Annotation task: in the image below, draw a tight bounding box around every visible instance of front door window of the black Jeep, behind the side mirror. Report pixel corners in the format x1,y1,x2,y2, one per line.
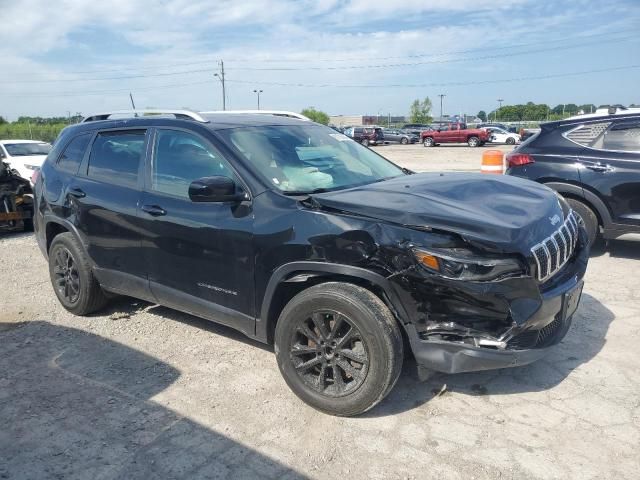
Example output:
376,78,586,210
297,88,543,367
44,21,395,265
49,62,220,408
151,129,236,198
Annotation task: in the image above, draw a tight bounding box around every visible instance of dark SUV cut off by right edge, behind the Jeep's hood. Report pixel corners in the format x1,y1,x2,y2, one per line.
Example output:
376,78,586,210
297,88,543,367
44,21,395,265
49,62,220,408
507,108,640,243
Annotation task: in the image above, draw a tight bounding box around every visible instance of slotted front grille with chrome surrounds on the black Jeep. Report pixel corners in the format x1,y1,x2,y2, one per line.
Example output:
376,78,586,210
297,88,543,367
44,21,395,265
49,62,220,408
531,210,578,282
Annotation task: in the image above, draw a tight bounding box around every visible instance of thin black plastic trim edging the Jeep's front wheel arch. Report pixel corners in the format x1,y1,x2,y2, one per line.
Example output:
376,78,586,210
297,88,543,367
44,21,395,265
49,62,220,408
255,262,408,342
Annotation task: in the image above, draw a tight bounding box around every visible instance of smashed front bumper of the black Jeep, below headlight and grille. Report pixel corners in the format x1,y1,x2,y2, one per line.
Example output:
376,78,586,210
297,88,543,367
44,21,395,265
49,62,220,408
389,228,588,373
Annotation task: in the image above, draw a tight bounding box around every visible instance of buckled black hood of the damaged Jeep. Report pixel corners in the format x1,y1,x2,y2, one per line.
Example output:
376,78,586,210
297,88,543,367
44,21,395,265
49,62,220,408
313,173,565,254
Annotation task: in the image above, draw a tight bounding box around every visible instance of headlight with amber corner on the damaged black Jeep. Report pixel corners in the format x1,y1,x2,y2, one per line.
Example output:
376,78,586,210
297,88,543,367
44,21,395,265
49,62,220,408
413,248,525,282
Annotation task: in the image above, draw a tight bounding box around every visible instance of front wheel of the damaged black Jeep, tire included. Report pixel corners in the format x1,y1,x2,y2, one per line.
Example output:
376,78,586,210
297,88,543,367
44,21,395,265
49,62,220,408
275,282,403,417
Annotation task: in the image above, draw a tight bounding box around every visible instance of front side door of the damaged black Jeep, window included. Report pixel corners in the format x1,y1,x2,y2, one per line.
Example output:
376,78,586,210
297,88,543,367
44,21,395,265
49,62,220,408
140,128,255,335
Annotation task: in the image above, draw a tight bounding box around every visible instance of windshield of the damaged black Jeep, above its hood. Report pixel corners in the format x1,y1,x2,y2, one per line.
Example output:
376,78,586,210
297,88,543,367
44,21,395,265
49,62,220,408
218,125,404,193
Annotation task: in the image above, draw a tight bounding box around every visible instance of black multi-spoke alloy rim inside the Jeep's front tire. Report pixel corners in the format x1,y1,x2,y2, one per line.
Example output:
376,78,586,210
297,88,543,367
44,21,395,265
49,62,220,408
290,310,369,397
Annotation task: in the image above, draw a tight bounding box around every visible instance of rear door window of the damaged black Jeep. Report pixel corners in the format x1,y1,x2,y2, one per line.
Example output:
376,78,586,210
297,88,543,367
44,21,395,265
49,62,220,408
87,130,145,186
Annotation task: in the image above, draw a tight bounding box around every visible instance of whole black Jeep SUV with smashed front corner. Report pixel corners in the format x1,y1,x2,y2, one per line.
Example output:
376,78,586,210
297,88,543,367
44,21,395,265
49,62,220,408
35,112,588,415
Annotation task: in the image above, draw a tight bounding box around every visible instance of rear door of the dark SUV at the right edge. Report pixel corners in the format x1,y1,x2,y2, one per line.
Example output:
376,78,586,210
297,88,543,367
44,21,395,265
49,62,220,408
579,119,640,226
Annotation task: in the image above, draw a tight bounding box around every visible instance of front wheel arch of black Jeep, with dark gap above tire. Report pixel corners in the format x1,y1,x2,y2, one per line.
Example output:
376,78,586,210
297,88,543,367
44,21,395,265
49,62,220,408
256,262,408,343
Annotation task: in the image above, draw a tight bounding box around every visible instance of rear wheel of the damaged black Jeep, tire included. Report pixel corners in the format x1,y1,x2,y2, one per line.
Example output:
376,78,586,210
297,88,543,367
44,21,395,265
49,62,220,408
49,233,107,315
